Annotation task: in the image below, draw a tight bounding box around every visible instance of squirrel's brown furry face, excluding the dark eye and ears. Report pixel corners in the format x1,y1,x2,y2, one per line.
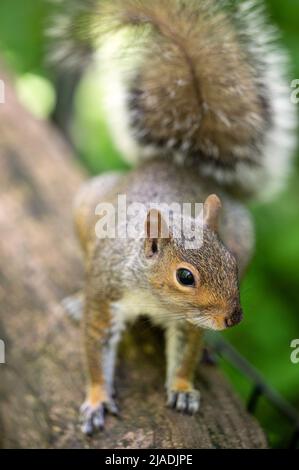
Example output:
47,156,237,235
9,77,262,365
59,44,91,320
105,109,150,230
149,227,242,330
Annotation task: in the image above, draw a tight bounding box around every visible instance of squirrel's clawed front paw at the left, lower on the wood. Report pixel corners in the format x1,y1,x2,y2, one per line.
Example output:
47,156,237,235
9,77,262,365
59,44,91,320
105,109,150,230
80,400,118,436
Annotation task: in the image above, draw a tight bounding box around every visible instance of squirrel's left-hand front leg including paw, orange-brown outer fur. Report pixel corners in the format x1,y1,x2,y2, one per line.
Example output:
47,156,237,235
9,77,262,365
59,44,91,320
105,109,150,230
81,300,121,434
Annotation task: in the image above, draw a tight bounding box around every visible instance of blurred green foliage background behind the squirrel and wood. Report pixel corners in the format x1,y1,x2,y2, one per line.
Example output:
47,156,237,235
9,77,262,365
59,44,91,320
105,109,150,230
0,0,299,446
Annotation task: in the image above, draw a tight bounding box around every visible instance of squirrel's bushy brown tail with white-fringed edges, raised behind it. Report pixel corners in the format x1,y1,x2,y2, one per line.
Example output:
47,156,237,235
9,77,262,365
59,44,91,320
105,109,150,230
51,0,296,195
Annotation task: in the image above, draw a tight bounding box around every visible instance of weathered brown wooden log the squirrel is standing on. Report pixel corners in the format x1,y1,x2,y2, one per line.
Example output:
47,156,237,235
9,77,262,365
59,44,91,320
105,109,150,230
0,69,266,448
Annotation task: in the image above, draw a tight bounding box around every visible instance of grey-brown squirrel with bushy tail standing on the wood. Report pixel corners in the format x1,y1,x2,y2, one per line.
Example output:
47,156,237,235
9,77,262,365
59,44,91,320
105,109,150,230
56,0,296,434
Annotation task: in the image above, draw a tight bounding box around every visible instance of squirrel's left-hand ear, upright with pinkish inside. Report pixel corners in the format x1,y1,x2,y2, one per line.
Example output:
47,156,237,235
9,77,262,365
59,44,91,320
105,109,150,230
145,209,171,258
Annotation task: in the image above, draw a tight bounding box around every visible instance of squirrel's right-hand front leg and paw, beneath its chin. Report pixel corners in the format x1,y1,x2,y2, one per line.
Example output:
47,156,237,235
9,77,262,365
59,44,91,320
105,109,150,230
166,323,203,414
